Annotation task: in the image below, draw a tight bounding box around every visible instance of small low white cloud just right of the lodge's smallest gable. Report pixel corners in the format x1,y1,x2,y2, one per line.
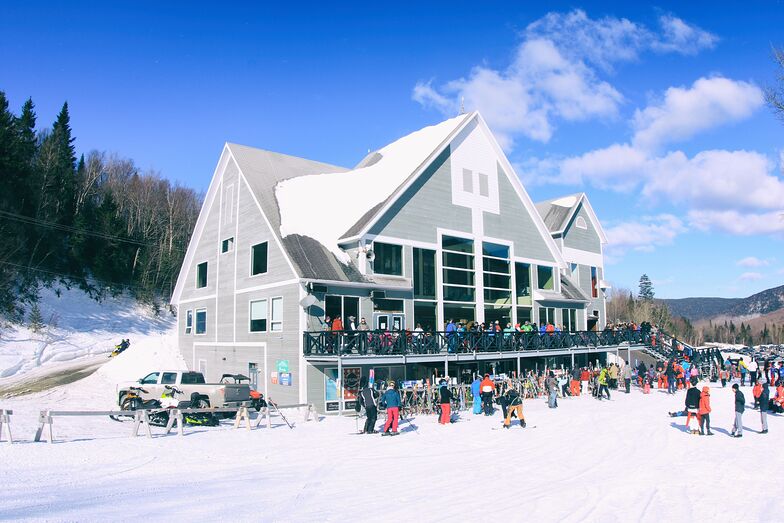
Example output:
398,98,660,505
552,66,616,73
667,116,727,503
605,214,686,257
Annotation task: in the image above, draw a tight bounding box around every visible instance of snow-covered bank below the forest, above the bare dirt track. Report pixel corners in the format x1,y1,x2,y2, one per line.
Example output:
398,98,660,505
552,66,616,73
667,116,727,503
0,288,176,389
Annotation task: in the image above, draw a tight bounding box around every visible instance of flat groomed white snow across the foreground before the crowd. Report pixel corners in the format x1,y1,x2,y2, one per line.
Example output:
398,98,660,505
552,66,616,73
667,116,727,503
0,374,784,522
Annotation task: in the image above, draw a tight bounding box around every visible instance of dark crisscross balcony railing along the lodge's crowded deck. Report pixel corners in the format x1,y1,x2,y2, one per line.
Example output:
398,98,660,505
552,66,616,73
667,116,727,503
303,330,650,356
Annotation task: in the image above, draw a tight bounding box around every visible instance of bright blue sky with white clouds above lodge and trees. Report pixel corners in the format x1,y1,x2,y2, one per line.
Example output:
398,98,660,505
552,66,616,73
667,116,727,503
0,1,784,297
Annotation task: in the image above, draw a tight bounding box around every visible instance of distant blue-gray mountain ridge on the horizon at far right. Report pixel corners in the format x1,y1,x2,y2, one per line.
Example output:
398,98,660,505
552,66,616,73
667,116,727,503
660,285,784,321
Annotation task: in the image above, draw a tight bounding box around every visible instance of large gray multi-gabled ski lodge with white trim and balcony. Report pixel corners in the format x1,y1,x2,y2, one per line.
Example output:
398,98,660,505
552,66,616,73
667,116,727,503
172,112,636,412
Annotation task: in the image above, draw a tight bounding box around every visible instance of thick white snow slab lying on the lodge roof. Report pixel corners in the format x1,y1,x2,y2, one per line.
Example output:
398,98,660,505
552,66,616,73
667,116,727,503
275,114,471,263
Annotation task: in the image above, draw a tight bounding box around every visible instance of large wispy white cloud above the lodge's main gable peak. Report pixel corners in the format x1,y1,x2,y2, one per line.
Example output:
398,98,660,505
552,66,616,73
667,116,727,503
412,10,715,150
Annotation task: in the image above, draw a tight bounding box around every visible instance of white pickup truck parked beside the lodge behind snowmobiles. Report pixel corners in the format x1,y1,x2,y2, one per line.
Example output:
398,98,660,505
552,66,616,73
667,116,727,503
117,370,250,408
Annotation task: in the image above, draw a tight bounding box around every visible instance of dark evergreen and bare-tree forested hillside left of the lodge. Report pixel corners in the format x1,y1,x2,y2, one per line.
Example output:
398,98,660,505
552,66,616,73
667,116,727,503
0,91,201,321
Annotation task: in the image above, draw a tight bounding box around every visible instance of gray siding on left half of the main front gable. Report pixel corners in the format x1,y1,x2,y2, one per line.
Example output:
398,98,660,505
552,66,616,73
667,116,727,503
370,148,471,243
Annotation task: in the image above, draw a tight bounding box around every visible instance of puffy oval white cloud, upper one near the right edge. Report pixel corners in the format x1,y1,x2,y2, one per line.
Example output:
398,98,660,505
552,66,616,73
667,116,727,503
632,77,764,150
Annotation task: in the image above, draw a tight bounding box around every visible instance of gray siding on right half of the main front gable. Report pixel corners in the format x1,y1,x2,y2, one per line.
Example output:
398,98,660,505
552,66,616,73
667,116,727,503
484,165,555,262
